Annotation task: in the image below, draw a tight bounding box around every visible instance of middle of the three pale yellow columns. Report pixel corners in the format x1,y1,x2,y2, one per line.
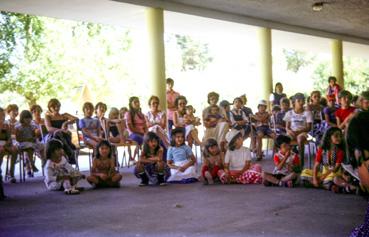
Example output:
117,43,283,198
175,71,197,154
258,27,273,101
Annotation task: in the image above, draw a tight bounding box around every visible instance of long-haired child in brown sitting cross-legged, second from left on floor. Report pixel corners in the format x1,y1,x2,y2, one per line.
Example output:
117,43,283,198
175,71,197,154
87,140,122,188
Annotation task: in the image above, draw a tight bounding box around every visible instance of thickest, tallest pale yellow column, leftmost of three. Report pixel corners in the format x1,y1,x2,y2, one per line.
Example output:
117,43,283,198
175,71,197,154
145,8,167,110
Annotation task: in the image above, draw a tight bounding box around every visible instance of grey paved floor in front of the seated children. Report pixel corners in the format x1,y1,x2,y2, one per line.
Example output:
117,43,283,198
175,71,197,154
0,155,367,237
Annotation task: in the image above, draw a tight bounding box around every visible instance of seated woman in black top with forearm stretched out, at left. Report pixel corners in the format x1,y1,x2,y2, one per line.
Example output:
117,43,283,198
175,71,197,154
45,99,78,164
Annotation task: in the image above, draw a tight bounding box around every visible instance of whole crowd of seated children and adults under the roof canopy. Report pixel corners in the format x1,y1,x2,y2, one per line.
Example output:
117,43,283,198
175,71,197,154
0,77,369,235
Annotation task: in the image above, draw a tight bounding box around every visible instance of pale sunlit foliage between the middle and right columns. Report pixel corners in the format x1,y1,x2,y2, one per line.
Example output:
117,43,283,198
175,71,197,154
283,49,315,73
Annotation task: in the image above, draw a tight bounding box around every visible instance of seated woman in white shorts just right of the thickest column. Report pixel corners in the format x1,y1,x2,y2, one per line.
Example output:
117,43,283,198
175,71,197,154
173,96,202,147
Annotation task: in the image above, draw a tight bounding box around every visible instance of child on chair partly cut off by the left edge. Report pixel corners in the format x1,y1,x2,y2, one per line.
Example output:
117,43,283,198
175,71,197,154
0,107,17,183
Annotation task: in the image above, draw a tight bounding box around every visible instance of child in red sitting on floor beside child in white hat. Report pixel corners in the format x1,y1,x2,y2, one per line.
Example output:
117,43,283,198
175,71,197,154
201,138,224,184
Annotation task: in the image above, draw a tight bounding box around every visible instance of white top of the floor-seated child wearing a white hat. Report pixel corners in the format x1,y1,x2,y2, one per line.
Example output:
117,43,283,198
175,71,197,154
224,147,251,170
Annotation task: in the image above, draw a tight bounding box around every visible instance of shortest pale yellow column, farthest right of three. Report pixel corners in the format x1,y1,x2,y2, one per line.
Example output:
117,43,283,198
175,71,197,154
331,39,344,88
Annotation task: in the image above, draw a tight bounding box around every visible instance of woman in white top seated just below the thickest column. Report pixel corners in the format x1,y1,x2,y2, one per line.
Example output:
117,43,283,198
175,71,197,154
145,95,169,148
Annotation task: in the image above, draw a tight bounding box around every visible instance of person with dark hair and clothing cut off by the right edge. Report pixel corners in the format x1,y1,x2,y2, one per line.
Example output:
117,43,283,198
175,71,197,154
347,98,369,237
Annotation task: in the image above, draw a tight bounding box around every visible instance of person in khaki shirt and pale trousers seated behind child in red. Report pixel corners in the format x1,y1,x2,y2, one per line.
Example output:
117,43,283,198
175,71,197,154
202,92,229,147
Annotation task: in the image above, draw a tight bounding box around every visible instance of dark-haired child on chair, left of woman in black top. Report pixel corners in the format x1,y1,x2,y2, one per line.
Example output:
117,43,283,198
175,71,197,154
15,110,44,177
